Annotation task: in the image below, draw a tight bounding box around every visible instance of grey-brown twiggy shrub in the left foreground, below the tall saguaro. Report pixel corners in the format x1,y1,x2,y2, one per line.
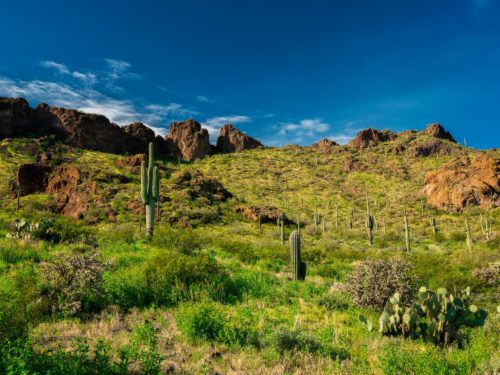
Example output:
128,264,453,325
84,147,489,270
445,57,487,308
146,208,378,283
40,253,107,315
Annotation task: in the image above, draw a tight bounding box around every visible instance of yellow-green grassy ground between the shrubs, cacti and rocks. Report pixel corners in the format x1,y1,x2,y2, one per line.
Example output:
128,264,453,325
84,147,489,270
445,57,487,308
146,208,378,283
0,136,500,374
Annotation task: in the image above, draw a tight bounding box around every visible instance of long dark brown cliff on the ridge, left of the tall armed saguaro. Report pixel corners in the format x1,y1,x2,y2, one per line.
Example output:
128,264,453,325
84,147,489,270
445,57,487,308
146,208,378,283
37,104,145,154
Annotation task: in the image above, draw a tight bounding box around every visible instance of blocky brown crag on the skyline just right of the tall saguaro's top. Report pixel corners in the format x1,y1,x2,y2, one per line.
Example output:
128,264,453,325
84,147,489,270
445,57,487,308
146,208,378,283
166,119,212,161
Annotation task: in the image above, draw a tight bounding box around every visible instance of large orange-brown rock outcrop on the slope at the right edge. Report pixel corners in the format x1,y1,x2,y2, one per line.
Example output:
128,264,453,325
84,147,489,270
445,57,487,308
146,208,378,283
422,154,500,211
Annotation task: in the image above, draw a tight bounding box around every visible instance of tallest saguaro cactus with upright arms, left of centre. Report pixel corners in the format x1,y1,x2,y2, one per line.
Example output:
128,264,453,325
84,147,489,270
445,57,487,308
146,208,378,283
141,142,160,237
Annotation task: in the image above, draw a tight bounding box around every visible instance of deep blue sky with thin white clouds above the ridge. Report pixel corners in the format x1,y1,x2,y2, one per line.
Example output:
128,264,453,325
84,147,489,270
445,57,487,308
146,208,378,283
0,0,500,148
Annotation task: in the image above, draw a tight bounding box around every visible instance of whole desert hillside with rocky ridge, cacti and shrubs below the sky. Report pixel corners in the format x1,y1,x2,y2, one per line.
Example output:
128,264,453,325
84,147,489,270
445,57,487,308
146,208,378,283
0,99,500,374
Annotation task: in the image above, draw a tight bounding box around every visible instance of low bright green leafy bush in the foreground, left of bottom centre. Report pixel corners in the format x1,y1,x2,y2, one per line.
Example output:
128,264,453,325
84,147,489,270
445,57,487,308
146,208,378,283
176,303,259,347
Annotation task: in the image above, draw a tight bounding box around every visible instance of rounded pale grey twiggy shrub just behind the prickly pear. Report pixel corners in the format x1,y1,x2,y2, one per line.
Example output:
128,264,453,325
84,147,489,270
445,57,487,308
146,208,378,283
346,260,418,309
